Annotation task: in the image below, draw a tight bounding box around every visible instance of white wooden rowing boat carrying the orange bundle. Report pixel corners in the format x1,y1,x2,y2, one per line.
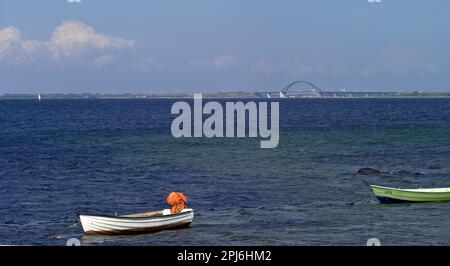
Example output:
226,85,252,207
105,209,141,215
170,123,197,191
79,209,194,235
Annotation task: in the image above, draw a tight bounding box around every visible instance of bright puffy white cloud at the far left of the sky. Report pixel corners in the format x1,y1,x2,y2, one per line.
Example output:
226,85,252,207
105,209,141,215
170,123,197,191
0,20,135,63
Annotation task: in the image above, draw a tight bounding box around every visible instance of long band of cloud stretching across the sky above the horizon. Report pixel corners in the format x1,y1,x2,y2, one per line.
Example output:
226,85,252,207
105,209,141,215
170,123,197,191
0,20,440,86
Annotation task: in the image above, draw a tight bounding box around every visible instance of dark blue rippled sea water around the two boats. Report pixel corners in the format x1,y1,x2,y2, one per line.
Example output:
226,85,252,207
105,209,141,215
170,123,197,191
0,99,450,245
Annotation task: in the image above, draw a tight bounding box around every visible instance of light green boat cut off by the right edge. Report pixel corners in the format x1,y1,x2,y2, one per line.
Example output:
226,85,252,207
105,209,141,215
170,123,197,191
370,185,450,203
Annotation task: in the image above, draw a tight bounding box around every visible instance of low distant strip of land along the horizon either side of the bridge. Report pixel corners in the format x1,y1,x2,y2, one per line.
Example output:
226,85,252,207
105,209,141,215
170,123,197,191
0,91,450,99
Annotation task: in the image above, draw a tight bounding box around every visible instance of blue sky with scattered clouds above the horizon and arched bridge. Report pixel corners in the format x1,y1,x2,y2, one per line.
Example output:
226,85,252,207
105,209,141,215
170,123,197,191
0,0,450,94
